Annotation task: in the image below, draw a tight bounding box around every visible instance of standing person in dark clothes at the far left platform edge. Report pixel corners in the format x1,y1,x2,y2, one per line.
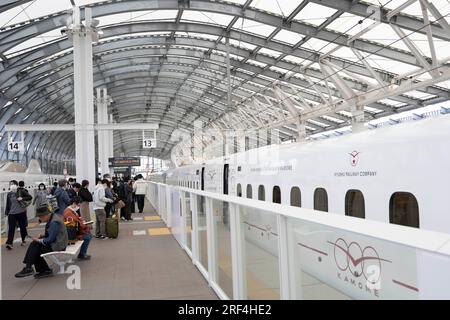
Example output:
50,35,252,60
5,180,33,250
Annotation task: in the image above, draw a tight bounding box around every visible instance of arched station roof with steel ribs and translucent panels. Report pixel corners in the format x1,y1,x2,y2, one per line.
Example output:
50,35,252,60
0,0,450,159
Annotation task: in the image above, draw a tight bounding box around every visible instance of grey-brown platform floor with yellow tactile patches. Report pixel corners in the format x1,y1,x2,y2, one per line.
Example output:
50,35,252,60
1,200,218,300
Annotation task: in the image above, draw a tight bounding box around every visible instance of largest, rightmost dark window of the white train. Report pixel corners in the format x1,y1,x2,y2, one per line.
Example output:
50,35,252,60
389,192,419,228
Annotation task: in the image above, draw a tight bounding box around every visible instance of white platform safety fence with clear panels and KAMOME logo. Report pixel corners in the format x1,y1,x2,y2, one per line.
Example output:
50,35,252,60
147,182,450,299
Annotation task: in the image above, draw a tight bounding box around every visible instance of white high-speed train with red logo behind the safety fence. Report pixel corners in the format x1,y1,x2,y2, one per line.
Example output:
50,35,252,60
165,116,450,233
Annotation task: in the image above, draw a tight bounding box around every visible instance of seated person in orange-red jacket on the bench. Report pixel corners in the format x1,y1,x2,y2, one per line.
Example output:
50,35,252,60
64,196,92,260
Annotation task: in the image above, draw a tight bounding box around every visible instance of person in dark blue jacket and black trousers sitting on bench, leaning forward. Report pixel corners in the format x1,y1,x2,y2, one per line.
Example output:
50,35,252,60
15,206,68,279
